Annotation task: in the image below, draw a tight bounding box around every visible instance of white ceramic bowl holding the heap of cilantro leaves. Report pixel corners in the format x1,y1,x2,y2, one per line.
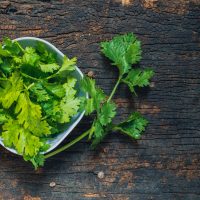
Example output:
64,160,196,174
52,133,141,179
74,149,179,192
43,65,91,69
0,37,87,154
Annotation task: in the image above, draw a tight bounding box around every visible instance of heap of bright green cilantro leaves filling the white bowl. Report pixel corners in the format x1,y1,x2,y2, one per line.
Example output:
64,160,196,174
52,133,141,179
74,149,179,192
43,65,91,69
0,38,80,168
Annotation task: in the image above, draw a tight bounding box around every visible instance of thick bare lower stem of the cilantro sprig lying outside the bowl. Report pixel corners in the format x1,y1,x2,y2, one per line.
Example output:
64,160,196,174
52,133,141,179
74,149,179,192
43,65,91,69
44,129,90,158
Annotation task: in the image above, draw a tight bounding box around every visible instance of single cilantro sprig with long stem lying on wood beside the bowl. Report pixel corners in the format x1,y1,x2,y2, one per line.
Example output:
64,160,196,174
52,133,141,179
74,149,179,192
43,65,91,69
45,33,154,162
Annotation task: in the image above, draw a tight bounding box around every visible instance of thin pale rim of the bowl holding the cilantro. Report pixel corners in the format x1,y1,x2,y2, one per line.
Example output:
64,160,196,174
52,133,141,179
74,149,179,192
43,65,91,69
0,37,85,156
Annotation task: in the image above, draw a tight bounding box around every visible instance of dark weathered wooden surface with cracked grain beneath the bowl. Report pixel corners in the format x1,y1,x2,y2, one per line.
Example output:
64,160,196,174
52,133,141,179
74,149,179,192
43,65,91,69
0,0,200,200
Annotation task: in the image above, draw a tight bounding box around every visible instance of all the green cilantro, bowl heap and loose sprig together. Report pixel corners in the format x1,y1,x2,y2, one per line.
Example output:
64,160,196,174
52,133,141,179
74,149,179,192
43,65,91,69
0,33,154,168
